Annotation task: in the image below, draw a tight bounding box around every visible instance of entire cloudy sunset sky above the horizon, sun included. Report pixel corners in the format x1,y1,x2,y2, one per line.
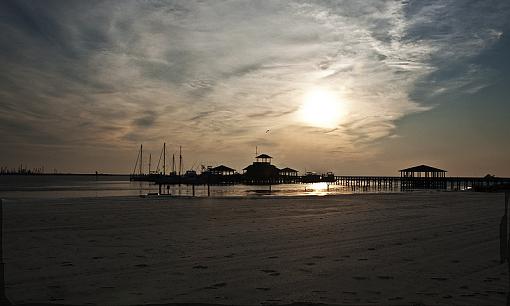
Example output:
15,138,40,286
0,0,510,177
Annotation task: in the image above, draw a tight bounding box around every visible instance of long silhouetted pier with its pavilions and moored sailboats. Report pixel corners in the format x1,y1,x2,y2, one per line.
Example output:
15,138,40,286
130,148,510,195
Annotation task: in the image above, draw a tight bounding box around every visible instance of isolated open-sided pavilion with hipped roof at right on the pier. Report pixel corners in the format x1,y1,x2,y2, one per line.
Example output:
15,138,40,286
399,165,447,189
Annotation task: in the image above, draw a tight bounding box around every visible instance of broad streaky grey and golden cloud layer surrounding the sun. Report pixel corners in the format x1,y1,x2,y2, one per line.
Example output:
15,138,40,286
0,0,510,172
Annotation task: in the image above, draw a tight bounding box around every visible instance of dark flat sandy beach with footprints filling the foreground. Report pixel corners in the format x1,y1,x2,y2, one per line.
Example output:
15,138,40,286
4,192,508,305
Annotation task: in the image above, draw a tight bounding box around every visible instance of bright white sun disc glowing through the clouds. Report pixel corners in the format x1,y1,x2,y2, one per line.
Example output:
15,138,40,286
299,89,345,129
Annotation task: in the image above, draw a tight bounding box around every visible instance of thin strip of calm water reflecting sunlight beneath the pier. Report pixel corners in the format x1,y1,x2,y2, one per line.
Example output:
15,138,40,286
0,175,399,199
